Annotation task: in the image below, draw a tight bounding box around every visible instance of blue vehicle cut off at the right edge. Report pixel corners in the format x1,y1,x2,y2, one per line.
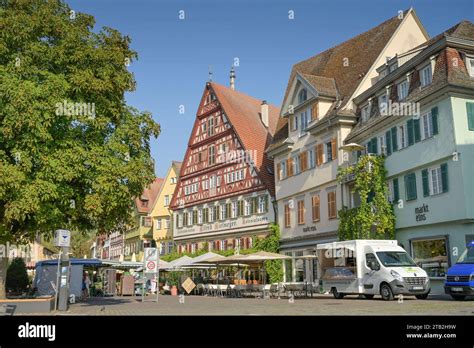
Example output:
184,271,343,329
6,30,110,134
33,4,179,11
444,241,474,301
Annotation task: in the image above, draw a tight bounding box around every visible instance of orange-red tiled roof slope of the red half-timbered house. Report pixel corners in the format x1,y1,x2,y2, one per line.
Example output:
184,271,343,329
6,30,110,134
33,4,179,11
209,82,280,195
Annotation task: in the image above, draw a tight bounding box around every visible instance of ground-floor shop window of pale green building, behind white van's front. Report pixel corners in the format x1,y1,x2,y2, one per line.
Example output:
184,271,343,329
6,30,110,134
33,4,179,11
411,237,449,278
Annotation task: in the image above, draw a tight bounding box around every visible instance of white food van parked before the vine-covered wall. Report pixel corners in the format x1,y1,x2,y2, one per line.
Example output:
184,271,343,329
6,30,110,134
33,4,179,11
317,240,431,301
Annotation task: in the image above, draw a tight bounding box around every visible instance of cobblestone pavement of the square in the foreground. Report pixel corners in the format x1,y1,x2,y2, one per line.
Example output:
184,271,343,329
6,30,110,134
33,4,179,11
23,294,474,316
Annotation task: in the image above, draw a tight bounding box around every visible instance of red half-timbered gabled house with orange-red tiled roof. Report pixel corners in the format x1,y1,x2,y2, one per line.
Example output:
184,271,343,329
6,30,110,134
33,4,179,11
170,79,279,253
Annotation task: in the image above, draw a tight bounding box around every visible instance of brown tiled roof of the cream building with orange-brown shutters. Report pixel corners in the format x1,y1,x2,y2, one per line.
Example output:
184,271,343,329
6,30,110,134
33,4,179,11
283,10,409,113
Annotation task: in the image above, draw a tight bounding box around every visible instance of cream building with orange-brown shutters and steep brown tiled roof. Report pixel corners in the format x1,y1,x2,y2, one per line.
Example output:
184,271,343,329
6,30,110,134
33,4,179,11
267,9,428,281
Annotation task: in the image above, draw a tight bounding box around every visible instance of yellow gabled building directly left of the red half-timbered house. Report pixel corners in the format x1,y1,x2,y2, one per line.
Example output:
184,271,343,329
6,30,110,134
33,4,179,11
150,161,181,255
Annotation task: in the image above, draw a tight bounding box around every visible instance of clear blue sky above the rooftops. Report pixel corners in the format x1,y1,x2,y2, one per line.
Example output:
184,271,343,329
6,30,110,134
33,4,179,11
66,0,474,176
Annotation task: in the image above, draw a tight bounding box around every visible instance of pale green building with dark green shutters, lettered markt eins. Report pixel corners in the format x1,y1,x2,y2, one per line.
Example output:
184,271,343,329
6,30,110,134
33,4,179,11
345,21,474,293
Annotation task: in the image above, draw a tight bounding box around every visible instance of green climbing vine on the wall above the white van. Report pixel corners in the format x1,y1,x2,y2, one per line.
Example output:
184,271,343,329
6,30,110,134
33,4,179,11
337,155,395,240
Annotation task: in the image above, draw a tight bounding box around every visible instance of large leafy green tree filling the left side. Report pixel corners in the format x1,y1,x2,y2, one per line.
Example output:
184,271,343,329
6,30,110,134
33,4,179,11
0,0,160,298
